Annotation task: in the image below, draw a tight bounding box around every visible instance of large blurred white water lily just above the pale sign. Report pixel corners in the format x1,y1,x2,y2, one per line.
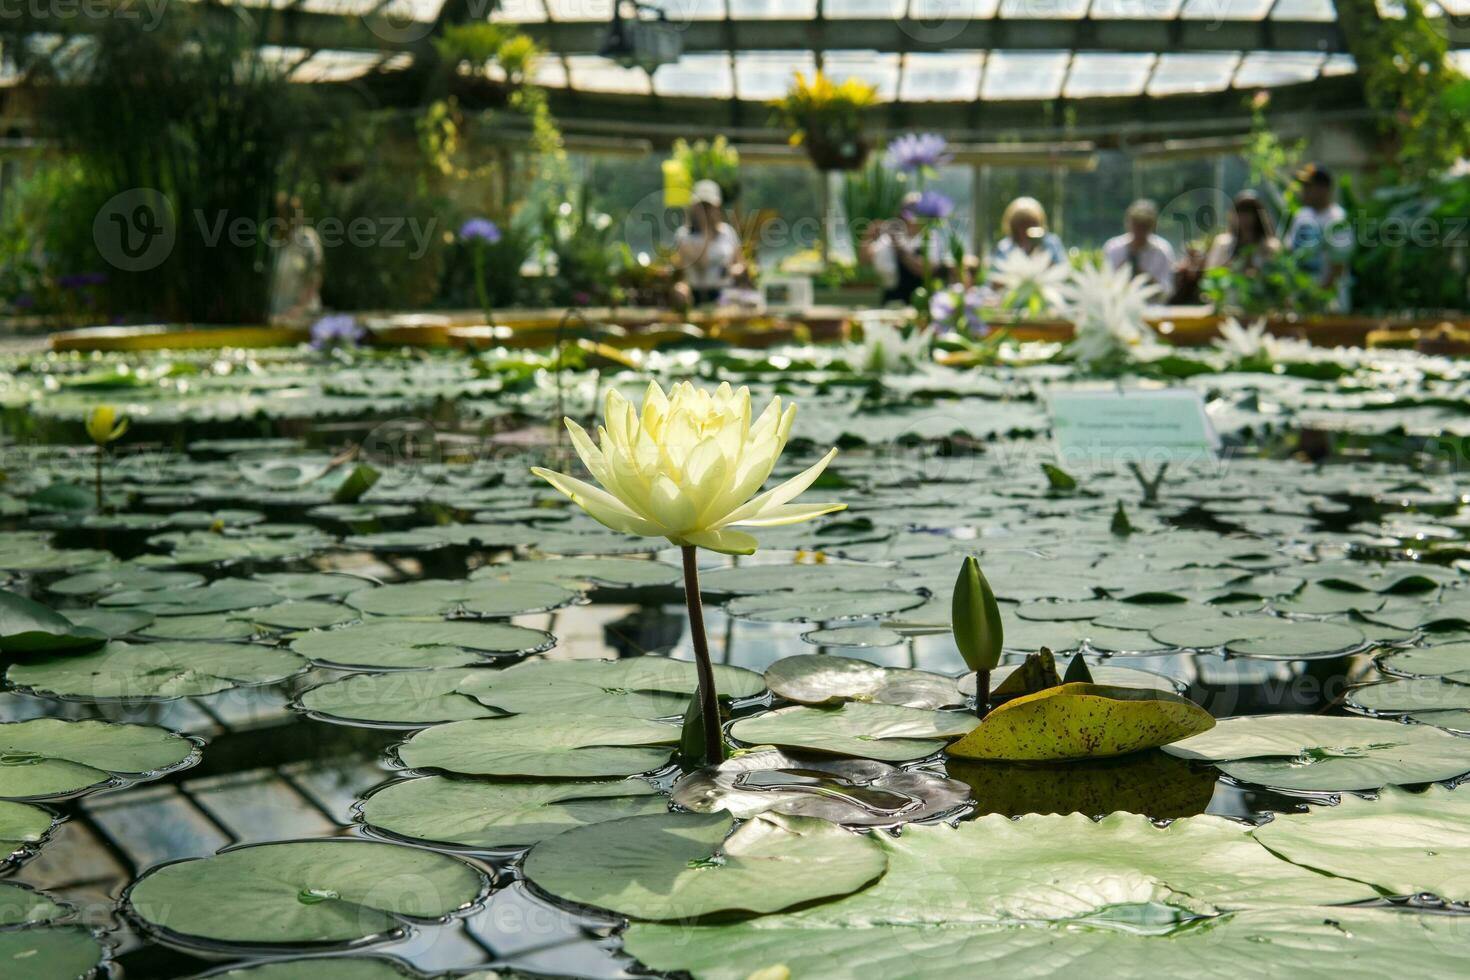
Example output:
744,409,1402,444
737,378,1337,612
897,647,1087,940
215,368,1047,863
1061,264,1169,364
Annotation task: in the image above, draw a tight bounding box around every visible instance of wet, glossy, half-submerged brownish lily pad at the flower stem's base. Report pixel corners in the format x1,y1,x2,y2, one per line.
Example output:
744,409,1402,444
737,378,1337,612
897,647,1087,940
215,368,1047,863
673,749,969,827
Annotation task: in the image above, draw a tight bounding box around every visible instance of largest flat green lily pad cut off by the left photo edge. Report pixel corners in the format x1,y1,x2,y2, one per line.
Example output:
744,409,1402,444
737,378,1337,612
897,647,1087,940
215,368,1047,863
0,718,198,799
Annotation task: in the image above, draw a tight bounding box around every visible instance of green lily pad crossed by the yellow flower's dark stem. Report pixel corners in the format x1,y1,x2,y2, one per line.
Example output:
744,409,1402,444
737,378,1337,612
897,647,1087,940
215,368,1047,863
460,657,766,718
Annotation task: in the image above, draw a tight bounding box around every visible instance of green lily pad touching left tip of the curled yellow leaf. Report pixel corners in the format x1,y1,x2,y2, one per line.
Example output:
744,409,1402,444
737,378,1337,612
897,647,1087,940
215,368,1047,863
731,701,979,763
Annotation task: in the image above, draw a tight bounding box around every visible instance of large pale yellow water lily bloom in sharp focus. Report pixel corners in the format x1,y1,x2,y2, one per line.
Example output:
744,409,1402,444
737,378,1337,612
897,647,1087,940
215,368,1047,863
531,382,847,554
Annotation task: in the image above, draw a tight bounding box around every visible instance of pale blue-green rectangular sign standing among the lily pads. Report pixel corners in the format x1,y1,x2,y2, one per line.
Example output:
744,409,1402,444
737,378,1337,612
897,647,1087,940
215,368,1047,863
1051,388,1220,469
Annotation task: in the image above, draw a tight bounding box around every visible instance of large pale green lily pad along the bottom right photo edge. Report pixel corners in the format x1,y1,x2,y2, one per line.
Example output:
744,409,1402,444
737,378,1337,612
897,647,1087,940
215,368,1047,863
623,910,1470,980
